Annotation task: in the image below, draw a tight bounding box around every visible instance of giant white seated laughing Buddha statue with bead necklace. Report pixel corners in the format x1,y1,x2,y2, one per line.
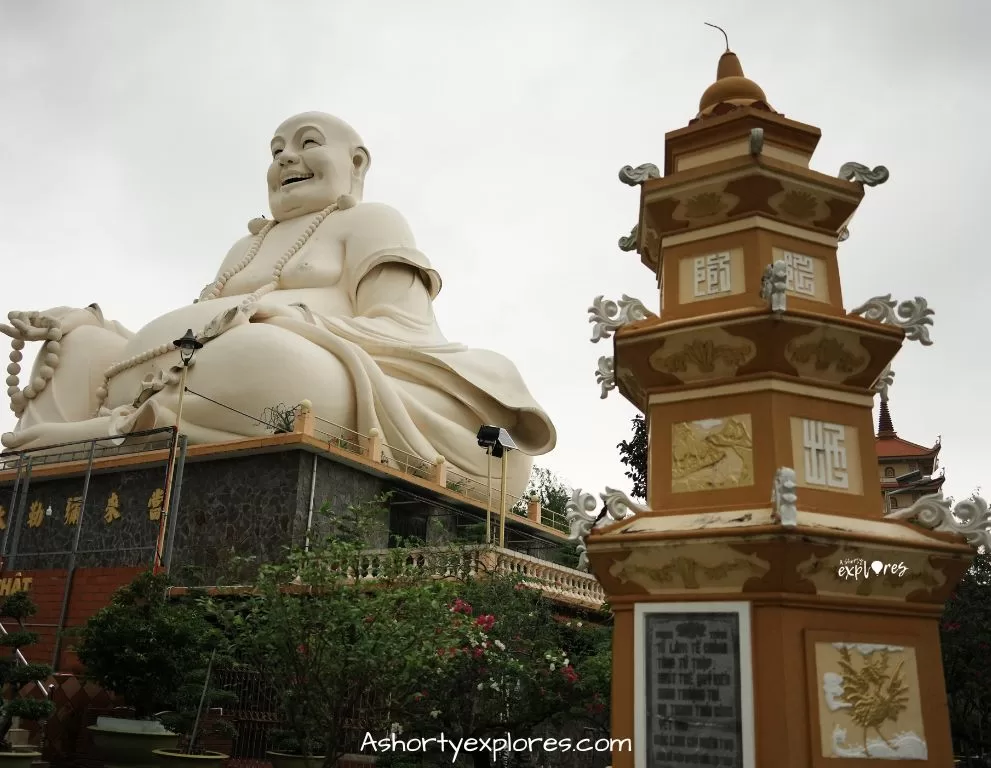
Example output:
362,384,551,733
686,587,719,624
0,113,556,495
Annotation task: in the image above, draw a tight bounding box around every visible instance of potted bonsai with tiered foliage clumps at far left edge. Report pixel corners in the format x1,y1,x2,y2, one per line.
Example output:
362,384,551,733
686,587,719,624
0,592,55,768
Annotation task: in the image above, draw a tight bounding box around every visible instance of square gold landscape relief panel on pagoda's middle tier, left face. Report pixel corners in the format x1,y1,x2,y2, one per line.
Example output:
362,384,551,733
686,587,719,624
671,414,754,493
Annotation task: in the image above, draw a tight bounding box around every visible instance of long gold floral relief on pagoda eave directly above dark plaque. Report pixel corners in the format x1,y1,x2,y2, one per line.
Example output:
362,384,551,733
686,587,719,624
609,544,769,592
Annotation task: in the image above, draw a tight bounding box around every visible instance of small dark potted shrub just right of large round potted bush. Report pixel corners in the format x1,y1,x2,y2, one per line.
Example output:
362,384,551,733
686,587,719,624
154,648,237,768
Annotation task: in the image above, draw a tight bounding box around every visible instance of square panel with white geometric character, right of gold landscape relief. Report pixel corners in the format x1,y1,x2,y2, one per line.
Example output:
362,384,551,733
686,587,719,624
791,418,864,495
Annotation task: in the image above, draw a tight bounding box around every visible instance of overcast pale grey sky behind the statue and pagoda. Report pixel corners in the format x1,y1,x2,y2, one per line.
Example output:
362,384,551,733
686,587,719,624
0,0,991,504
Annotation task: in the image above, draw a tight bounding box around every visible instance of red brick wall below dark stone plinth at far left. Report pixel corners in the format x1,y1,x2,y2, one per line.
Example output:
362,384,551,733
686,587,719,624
0,568,144,672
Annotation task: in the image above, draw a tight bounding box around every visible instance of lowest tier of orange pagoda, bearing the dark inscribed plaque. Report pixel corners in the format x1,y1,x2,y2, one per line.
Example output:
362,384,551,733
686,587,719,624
587,510,973,768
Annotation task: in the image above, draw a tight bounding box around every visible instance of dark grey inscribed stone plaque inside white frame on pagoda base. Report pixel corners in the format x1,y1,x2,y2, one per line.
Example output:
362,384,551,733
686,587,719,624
643,613,744,768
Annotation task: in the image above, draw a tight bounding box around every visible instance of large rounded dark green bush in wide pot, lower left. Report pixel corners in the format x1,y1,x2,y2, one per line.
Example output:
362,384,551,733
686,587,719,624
75,572,216,768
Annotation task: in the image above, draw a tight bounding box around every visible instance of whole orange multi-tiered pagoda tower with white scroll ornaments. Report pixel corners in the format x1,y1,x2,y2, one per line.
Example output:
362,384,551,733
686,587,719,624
569,40,991,768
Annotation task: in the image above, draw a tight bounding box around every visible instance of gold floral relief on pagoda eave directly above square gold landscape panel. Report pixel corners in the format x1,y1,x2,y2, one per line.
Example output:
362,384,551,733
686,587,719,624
649,328,757,382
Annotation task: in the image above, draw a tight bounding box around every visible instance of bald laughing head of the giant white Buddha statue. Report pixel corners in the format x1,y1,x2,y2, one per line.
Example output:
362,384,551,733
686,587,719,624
268,112,371,221
